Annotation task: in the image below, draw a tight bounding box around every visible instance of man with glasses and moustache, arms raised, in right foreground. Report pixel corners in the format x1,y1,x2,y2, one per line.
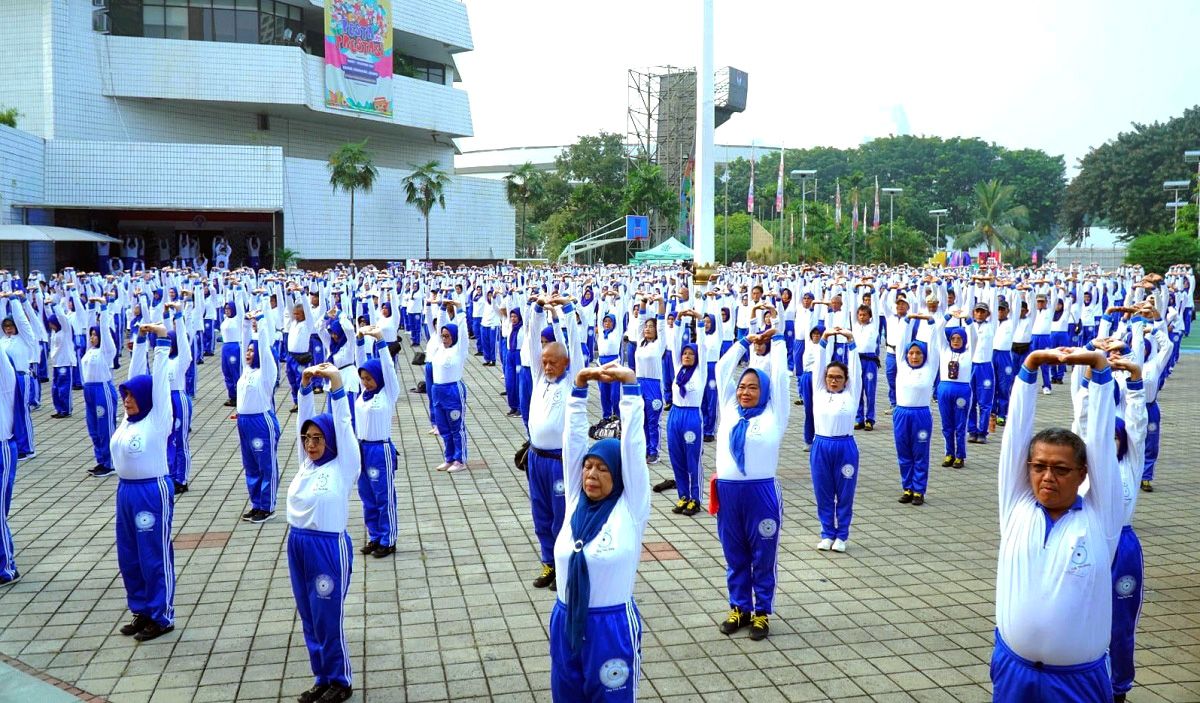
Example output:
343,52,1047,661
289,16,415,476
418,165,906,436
991,349,1123,703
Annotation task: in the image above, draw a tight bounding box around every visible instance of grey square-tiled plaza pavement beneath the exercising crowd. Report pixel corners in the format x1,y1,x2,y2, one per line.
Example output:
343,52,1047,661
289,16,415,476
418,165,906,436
0,345,1200,703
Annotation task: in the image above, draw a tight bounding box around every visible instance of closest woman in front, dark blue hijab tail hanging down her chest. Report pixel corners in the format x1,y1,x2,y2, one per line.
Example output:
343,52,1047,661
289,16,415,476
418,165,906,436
550,363,650,703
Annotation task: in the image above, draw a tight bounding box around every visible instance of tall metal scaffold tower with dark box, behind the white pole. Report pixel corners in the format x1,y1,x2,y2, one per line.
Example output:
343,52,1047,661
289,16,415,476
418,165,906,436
625,66,748,251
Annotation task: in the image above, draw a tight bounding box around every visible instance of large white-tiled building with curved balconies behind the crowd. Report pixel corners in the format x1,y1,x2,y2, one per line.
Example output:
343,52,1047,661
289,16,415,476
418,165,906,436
0,0,514,270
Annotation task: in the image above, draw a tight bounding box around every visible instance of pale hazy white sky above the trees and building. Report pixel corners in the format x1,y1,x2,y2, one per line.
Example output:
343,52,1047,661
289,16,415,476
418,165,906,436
457,0,1200,176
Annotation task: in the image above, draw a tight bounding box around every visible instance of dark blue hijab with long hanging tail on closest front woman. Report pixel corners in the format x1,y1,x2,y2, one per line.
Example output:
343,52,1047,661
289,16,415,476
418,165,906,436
566,439,625,651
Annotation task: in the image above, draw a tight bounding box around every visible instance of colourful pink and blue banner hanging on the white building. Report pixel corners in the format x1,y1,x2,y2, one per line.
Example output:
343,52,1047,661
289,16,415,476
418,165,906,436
325,0,392,118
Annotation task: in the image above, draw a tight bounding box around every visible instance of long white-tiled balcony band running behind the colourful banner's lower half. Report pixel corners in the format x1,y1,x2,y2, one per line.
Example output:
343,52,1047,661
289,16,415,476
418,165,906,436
101,34,473,137
